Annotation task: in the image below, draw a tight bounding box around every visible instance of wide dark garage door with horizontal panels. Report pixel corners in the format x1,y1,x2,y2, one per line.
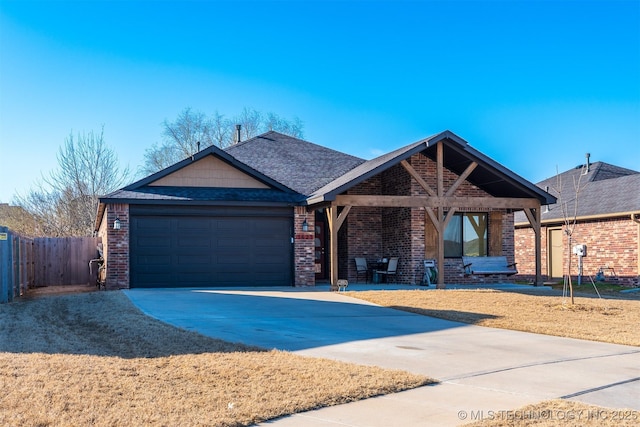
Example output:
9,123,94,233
130,206,293,288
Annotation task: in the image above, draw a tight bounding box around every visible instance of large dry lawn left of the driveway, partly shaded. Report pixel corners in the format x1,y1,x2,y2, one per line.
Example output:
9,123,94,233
0,292,430,426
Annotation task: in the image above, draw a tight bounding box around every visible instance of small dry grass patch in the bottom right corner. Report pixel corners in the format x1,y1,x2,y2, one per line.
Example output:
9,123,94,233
465,400,640,427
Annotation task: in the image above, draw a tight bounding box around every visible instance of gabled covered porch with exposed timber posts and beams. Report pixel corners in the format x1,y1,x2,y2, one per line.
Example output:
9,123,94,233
305,132,554,288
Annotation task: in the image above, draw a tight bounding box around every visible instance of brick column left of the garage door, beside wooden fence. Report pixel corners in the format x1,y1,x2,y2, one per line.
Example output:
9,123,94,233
105,203,129,290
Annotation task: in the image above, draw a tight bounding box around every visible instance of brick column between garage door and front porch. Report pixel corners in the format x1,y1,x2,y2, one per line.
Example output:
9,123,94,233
293,206,316,286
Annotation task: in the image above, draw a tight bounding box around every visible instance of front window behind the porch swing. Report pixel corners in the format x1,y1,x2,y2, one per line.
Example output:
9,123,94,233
444,213,487,258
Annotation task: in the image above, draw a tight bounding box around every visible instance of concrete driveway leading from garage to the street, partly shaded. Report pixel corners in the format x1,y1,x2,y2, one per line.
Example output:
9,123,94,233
124,288,640,427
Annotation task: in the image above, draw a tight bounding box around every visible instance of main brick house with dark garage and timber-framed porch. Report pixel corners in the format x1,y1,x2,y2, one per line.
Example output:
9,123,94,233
96,131,555,289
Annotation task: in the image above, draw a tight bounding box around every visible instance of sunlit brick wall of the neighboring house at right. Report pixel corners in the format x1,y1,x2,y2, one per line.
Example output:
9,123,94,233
515,216,640,284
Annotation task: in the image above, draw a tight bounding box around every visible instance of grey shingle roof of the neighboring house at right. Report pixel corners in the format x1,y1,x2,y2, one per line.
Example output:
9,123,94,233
514,162,640,224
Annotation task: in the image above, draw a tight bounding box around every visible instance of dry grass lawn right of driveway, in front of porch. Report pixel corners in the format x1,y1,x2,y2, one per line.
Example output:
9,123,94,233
347,290,640,346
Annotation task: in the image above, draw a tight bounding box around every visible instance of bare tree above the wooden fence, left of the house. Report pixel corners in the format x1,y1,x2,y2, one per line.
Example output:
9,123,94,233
16,128,129,236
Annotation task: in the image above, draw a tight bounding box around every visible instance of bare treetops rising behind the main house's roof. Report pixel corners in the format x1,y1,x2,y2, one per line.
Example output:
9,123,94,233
141,107,304,175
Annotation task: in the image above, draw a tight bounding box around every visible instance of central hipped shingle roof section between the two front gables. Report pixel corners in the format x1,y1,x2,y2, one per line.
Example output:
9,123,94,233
225,131,364,195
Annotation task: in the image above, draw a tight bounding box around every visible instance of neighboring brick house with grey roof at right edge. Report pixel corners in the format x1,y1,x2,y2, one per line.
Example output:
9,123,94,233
515,157,640,284
